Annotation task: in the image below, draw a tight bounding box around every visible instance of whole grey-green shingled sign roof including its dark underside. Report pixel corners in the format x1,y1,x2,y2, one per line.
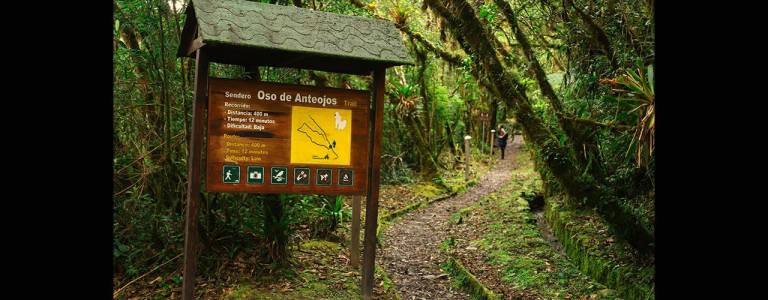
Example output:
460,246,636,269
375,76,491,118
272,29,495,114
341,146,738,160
178,0,413,74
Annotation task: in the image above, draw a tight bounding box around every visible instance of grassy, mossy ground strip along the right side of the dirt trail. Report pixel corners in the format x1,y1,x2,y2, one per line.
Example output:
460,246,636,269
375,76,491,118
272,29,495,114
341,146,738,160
438,146,617,299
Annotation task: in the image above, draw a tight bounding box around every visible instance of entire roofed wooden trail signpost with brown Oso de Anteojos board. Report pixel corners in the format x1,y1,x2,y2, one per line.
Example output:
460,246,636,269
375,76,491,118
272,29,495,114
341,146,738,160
177,0,413,300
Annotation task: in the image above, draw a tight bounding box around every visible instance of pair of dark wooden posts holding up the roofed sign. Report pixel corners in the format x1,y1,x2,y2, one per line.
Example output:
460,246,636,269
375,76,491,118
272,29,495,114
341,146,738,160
182,46,385,300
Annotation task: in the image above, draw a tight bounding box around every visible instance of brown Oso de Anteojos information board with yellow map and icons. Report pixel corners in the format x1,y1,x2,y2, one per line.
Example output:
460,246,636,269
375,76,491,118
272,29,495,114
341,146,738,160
206,78,370,195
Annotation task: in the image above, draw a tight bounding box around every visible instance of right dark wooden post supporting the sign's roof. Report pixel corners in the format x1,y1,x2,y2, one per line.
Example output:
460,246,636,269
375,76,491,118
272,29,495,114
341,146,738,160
362,67,386,300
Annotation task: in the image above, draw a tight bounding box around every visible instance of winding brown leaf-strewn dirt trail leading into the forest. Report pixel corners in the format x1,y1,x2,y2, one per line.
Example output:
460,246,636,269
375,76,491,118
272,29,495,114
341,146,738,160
381,136,522,300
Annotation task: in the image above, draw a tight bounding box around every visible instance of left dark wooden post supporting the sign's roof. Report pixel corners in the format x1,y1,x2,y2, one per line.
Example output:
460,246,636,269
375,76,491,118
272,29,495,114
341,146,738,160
181,49,208,300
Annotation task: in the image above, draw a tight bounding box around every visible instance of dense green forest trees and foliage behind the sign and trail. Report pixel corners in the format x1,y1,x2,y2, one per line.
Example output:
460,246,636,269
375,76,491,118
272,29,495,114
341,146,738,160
113,0,655,296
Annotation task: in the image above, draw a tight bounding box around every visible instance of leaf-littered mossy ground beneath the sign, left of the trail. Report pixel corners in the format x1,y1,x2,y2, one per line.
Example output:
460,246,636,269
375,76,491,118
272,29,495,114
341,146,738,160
116,155,490,299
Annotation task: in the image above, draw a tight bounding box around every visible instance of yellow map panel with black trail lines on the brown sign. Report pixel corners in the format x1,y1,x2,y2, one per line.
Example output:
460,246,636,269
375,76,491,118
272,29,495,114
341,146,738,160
291,106,352,165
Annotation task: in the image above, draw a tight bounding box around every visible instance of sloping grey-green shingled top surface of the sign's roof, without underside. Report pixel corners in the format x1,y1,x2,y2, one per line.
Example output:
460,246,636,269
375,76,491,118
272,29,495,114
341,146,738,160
187,0,413,65
